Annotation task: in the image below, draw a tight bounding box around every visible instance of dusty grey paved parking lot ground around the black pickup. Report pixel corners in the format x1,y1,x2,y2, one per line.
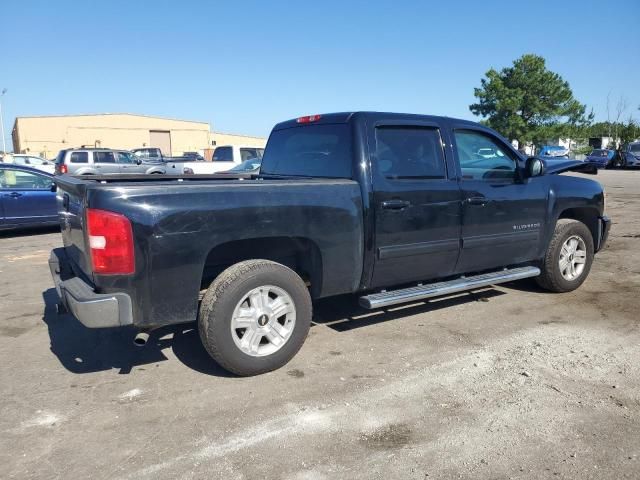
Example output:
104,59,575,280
0,171,640,479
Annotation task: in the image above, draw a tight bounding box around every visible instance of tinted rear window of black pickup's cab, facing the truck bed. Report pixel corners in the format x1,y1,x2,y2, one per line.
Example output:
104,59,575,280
260,124,351,178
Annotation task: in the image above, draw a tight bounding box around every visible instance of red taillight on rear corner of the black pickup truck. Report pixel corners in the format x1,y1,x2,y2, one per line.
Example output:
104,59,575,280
87,208,135,275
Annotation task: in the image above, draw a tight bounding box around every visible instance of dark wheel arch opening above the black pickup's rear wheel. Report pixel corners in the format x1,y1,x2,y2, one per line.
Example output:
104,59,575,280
202,237,323,298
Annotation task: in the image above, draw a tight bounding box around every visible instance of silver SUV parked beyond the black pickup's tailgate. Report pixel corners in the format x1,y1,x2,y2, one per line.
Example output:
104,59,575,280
55,148,166,175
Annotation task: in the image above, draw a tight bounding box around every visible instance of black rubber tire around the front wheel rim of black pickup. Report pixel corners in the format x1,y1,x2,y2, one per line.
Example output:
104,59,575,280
536,218,594,293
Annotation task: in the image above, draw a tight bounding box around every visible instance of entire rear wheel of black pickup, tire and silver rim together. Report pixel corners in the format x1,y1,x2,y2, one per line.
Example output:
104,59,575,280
198,260,312,376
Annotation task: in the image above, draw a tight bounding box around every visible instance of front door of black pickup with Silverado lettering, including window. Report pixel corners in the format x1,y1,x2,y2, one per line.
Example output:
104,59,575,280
453,126,547,273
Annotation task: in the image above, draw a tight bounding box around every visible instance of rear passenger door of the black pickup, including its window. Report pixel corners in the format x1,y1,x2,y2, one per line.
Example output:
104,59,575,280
369,124,461,287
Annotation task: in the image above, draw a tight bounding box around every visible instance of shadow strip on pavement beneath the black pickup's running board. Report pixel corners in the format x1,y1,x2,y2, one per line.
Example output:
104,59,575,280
313,287,505,332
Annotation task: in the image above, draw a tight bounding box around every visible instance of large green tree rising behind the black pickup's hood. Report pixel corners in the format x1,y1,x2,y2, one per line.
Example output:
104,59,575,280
469,54,593,145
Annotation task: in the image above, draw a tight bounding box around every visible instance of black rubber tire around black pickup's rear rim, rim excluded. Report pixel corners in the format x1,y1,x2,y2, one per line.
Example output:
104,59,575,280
198,260,312,376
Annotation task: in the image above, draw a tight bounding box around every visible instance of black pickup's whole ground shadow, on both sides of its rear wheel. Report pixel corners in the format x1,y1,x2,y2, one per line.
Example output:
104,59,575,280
42,287,505,378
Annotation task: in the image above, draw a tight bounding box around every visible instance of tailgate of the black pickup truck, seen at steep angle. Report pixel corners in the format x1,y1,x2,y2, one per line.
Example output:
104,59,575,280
55,175,92,278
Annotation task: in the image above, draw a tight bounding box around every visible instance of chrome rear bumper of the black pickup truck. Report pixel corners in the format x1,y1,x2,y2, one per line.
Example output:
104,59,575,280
49,248,133,328
